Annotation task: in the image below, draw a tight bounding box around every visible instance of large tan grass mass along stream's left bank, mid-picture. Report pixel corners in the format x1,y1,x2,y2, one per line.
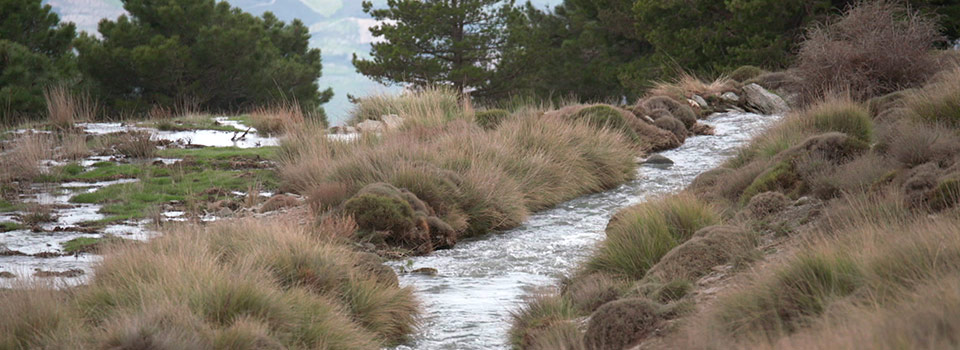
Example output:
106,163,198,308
280,104,636,250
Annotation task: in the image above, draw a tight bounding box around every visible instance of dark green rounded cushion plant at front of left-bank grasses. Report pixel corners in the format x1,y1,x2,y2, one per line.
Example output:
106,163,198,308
343,193,415,233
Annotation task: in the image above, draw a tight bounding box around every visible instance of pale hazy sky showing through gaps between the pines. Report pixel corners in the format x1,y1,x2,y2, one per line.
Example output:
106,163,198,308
44,0,562,125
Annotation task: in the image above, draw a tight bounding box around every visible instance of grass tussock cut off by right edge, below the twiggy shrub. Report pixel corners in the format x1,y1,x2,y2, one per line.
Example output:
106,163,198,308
904,68,960,128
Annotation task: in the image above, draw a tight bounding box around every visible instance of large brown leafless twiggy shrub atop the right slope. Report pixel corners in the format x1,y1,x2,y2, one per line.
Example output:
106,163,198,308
797,0,941,101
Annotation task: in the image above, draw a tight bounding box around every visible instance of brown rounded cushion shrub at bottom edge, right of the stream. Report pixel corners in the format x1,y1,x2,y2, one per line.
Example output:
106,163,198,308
583,298,662,350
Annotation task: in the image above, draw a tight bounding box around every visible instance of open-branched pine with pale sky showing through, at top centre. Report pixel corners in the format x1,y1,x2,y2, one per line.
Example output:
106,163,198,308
353,0,506,92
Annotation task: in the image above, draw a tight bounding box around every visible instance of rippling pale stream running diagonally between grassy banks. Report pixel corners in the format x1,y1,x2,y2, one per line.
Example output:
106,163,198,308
393,113,777,349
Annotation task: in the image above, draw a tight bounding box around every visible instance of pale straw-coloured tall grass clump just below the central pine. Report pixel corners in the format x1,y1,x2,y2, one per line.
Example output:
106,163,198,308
347,86,473,127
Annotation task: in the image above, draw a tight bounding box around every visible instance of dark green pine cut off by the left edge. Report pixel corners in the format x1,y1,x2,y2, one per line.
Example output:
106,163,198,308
0,0,76,119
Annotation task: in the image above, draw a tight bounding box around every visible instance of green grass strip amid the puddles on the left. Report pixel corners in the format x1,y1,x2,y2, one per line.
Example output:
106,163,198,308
70,169,278,221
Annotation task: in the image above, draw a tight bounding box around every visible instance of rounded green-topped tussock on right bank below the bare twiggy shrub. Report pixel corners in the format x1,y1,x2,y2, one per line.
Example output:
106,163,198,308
806,100,873,144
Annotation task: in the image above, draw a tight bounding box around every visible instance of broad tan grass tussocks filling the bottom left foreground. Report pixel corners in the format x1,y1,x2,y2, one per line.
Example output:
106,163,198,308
0,220,417,349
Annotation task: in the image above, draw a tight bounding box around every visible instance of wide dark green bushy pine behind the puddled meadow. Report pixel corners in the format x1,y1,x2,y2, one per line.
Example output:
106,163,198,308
77,0,332,113
